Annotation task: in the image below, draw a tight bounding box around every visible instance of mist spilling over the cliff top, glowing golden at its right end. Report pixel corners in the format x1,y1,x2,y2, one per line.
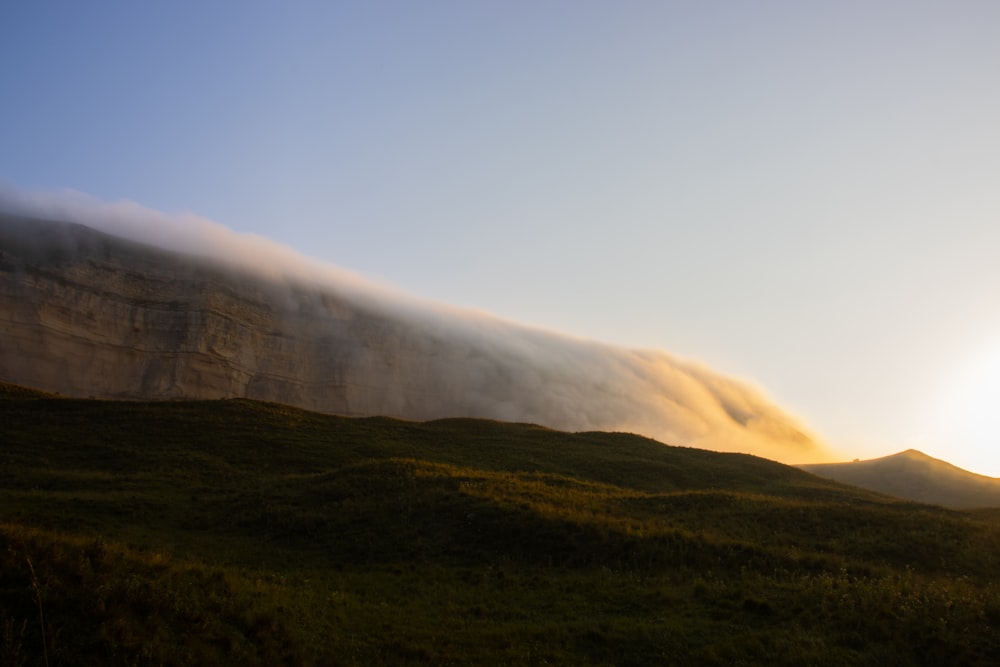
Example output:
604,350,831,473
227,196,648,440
0,184,827,463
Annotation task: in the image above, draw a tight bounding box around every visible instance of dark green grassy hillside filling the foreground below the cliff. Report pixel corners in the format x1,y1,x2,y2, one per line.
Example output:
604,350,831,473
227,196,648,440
0,387,1000,665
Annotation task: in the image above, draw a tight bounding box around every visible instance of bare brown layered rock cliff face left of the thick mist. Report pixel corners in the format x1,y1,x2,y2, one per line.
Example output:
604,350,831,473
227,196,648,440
0,218,435,418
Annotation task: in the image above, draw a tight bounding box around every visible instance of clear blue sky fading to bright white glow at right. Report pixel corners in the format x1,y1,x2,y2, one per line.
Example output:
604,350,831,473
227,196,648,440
0,0,1000,476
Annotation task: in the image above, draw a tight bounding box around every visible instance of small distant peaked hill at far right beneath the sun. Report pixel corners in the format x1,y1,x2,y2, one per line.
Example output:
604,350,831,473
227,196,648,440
798,449,1000,508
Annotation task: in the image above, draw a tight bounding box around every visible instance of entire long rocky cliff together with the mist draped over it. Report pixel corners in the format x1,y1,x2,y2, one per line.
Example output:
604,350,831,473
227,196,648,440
0,201,825,463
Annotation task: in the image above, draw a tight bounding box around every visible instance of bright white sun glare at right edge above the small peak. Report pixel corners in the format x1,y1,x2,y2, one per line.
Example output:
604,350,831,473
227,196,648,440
935,342,1000,477
